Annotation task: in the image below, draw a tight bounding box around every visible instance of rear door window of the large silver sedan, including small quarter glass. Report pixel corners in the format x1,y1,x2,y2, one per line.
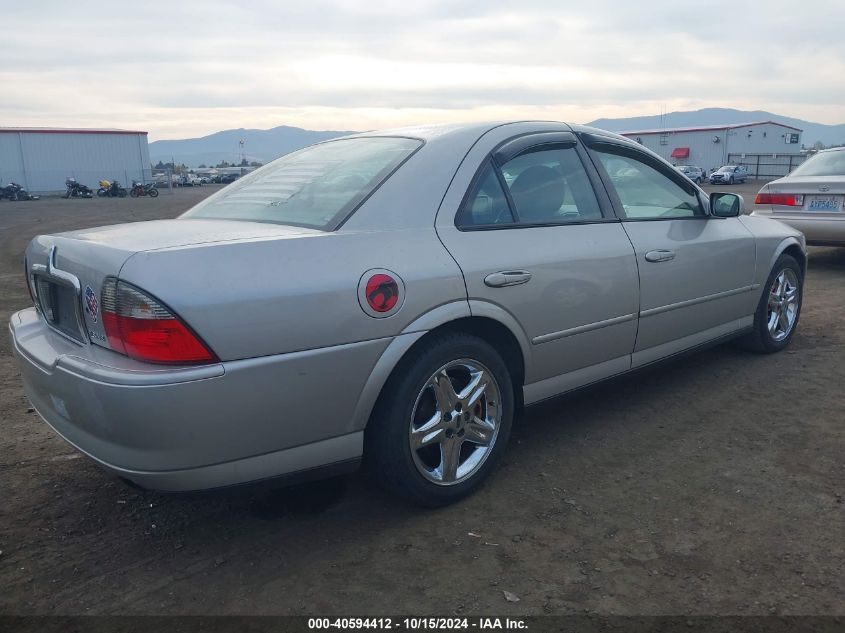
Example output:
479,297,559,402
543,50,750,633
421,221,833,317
457,146,602,228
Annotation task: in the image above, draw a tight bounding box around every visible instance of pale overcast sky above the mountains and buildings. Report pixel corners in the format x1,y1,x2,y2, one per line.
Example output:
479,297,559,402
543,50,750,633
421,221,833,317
0,0,845,140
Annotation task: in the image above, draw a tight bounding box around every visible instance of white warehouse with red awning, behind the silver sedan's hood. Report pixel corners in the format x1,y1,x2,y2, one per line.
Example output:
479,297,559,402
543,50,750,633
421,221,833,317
622,121,805,178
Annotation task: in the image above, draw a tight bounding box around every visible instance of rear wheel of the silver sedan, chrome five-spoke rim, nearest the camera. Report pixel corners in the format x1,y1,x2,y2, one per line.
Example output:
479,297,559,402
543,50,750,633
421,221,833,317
365,333,514,507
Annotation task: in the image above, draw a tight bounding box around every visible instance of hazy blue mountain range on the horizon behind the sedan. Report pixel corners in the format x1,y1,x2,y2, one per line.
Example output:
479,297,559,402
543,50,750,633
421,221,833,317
150,108,845,167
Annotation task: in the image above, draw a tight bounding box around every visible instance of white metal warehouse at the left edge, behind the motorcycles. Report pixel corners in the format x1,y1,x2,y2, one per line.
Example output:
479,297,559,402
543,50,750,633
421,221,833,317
0,127,150,193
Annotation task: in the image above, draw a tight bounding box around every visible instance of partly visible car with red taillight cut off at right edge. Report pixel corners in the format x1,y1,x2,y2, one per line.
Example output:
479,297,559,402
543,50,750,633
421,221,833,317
753,147,845,246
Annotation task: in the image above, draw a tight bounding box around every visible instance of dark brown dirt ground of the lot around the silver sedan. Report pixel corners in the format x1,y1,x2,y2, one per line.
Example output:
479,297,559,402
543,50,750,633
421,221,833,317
0,184,845,615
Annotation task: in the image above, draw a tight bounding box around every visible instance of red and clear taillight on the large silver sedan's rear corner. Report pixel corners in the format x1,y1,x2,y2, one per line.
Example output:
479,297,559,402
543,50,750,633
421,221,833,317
100,278,216,364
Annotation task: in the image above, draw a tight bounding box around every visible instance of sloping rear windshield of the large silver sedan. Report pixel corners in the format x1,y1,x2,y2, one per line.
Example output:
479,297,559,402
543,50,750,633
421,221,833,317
181,137,422,231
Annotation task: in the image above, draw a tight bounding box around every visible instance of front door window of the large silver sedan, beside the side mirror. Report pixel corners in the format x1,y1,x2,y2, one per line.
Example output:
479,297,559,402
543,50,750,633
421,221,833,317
596,149,705,220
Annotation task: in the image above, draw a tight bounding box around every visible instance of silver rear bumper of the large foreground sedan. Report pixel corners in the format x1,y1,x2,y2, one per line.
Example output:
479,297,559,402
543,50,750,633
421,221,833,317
9,309,389,491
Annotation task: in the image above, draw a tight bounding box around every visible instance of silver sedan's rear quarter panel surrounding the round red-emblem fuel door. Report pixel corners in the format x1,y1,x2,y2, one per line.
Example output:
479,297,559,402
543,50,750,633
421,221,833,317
120,227,466,360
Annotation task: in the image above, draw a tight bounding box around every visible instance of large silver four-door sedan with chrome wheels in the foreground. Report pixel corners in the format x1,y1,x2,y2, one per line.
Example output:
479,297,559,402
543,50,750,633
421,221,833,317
10,122,806,505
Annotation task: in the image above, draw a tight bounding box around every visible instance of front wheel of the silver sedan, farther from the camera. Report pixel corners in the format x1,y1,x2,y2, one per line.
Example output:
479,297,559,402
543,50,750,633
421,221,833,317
741,255,804,354
